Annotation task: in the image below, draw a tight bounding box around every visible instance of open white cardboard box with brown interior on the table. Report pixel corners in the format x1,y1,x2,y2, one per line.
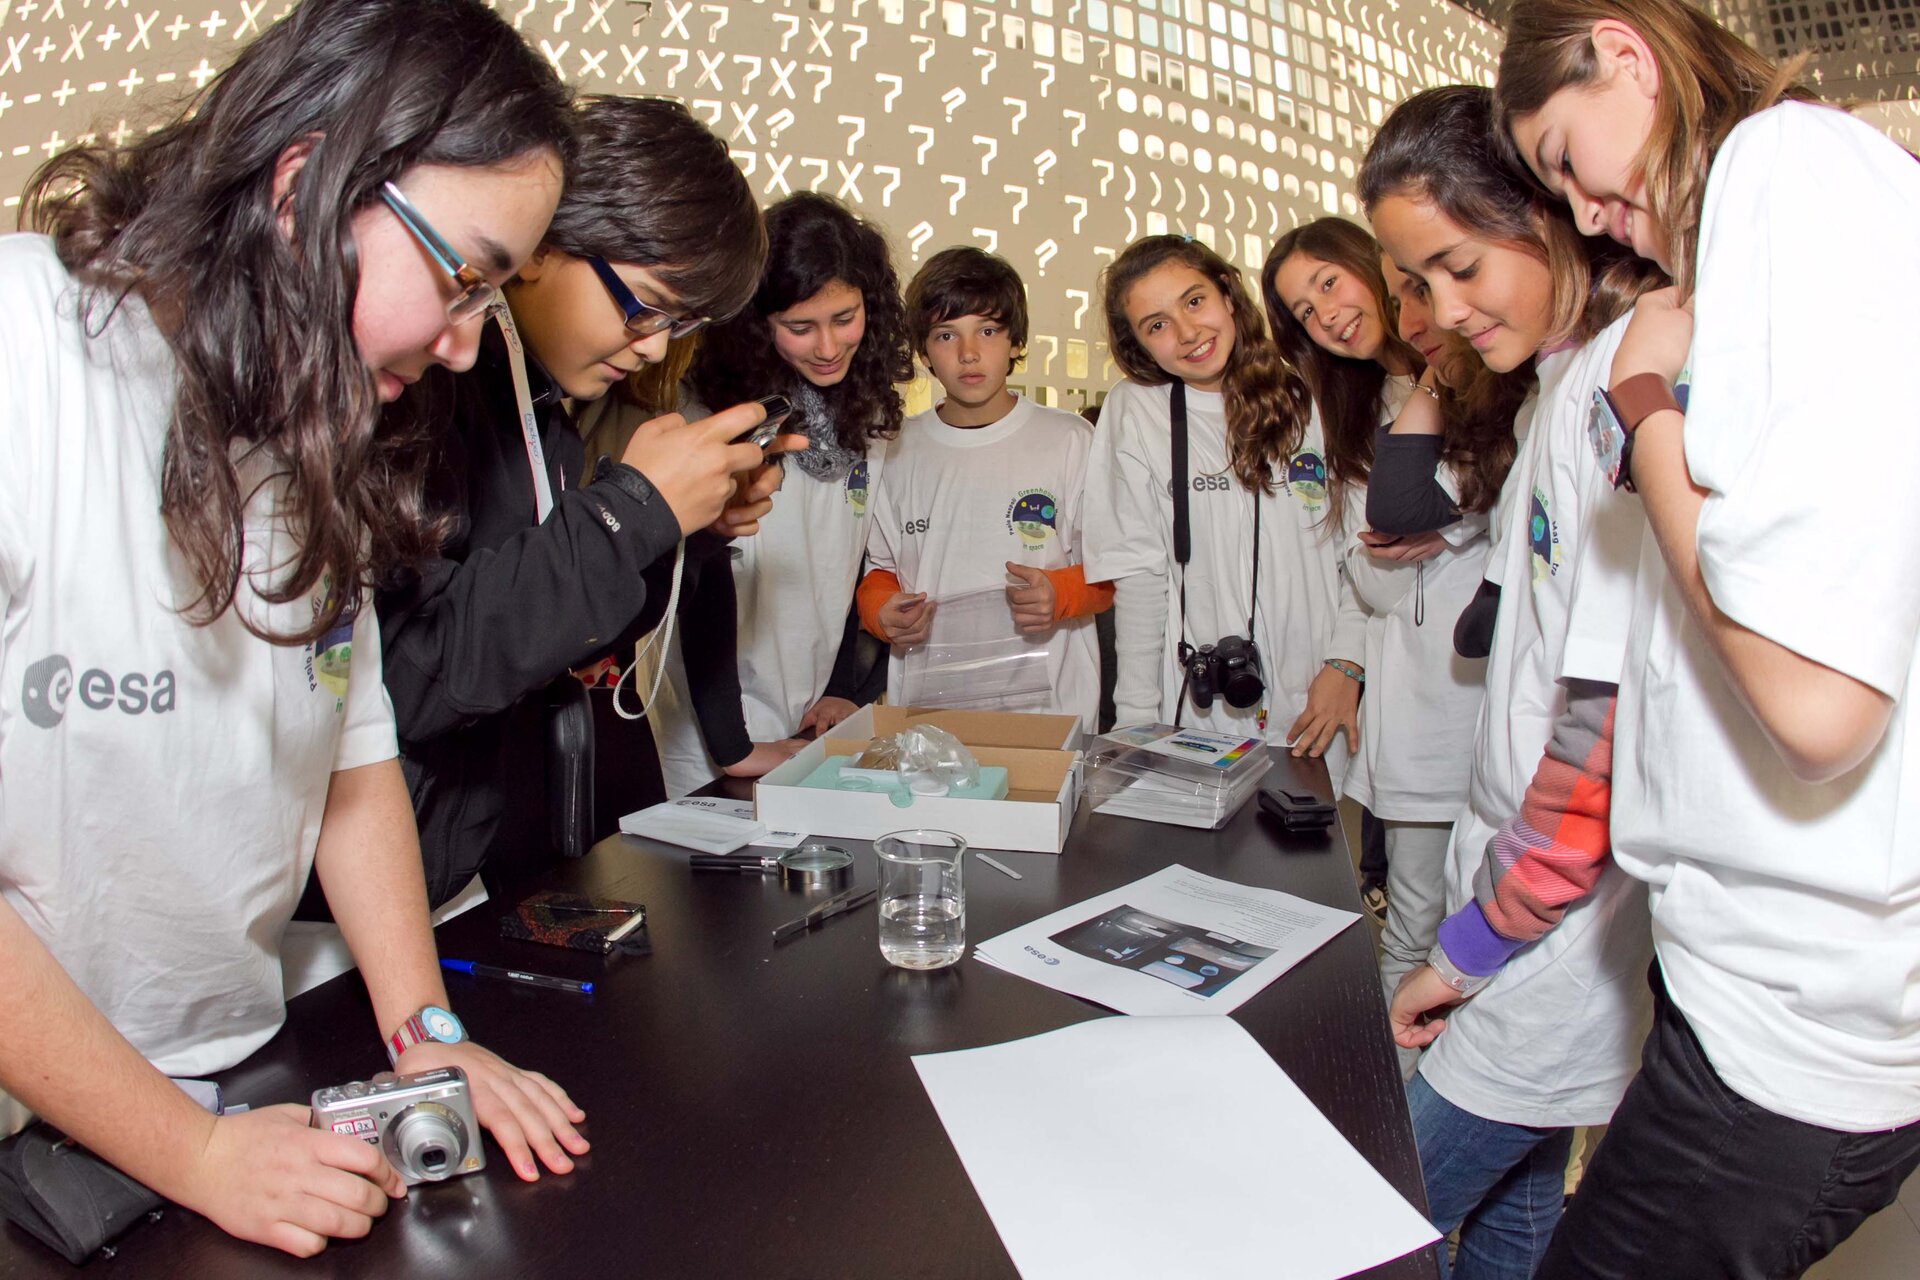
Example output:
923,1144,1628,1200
753,706,1079,854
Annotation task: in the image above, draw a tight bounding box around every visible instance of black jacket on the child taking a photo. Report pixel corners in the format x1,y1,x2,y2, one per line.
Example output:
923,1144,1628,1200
376,335,751,904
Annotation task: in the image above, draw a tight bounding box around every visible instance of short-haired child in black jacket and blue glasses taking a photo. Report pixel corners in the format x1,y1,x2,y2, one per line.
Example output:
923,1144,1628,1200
378,98,794,904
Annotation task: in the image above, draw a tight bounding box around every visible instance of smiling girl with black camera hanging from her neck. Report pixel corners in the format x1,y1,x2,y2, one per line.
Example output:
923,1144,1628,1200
1085,236,1361,754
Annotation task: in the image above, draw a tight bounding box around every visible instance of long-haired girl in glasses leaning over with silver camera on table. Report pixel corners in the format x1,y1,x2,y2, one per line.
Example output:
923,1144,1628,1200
0,0,588,1253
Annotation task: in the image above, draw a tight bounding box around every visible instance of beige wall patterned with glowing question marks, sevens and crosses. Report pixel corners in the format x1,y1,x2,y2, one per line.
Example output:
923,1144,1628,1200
0,0,1500,409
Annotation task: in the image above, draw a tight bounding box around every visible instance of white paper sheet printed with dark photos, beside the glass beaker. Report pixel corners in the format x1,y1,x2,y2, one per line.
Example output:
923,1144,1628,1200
973,865,1359,1015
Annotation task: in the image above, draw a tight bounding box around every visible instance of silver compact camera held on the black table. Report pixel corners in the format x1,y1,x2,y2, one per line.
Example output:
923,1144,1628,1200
311,1067,486,1186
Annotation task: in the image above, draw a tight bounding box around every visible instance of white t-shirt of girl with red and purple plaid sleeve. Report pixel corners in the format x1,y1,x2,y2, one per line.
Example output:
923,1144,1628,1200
1421,317,1651,1126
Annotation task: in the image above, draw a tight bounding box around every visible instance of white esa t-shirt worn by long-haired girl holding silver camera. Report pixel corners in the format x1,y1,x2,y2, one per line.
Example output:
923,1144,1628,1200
0,236,397,1075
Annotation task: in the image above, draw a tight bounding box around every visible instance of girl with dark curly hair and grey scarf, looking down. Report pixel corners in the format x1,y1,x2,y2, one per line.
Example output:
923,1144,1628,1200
655,192,914,796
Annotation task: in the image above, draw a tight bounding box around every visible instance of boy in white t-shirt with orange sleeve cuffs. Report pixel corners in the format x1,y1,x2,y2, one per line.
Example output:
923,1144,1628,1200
858,248,1114,731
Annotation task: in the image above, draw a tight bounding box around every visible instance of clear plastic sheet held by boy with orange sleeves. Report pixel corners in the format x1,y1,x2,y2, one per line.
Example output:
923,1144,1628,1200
900,587,1052,710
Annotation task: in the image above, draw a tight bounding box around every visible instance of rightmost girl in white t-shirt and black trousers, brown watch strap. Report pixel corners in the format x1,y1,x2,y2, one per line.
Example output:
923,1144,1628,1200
1498,0,1920,1276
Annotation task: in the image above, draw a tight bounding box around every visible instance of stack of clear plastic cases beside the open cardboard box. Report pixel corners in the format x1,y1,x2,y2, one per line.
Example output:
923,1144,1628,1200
1085,725,1273,829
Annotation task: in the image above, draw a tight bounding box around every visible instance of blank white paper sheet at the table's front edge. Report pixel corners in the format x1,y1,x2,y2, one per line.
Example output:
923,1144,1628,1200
914,1017,1440,1280
